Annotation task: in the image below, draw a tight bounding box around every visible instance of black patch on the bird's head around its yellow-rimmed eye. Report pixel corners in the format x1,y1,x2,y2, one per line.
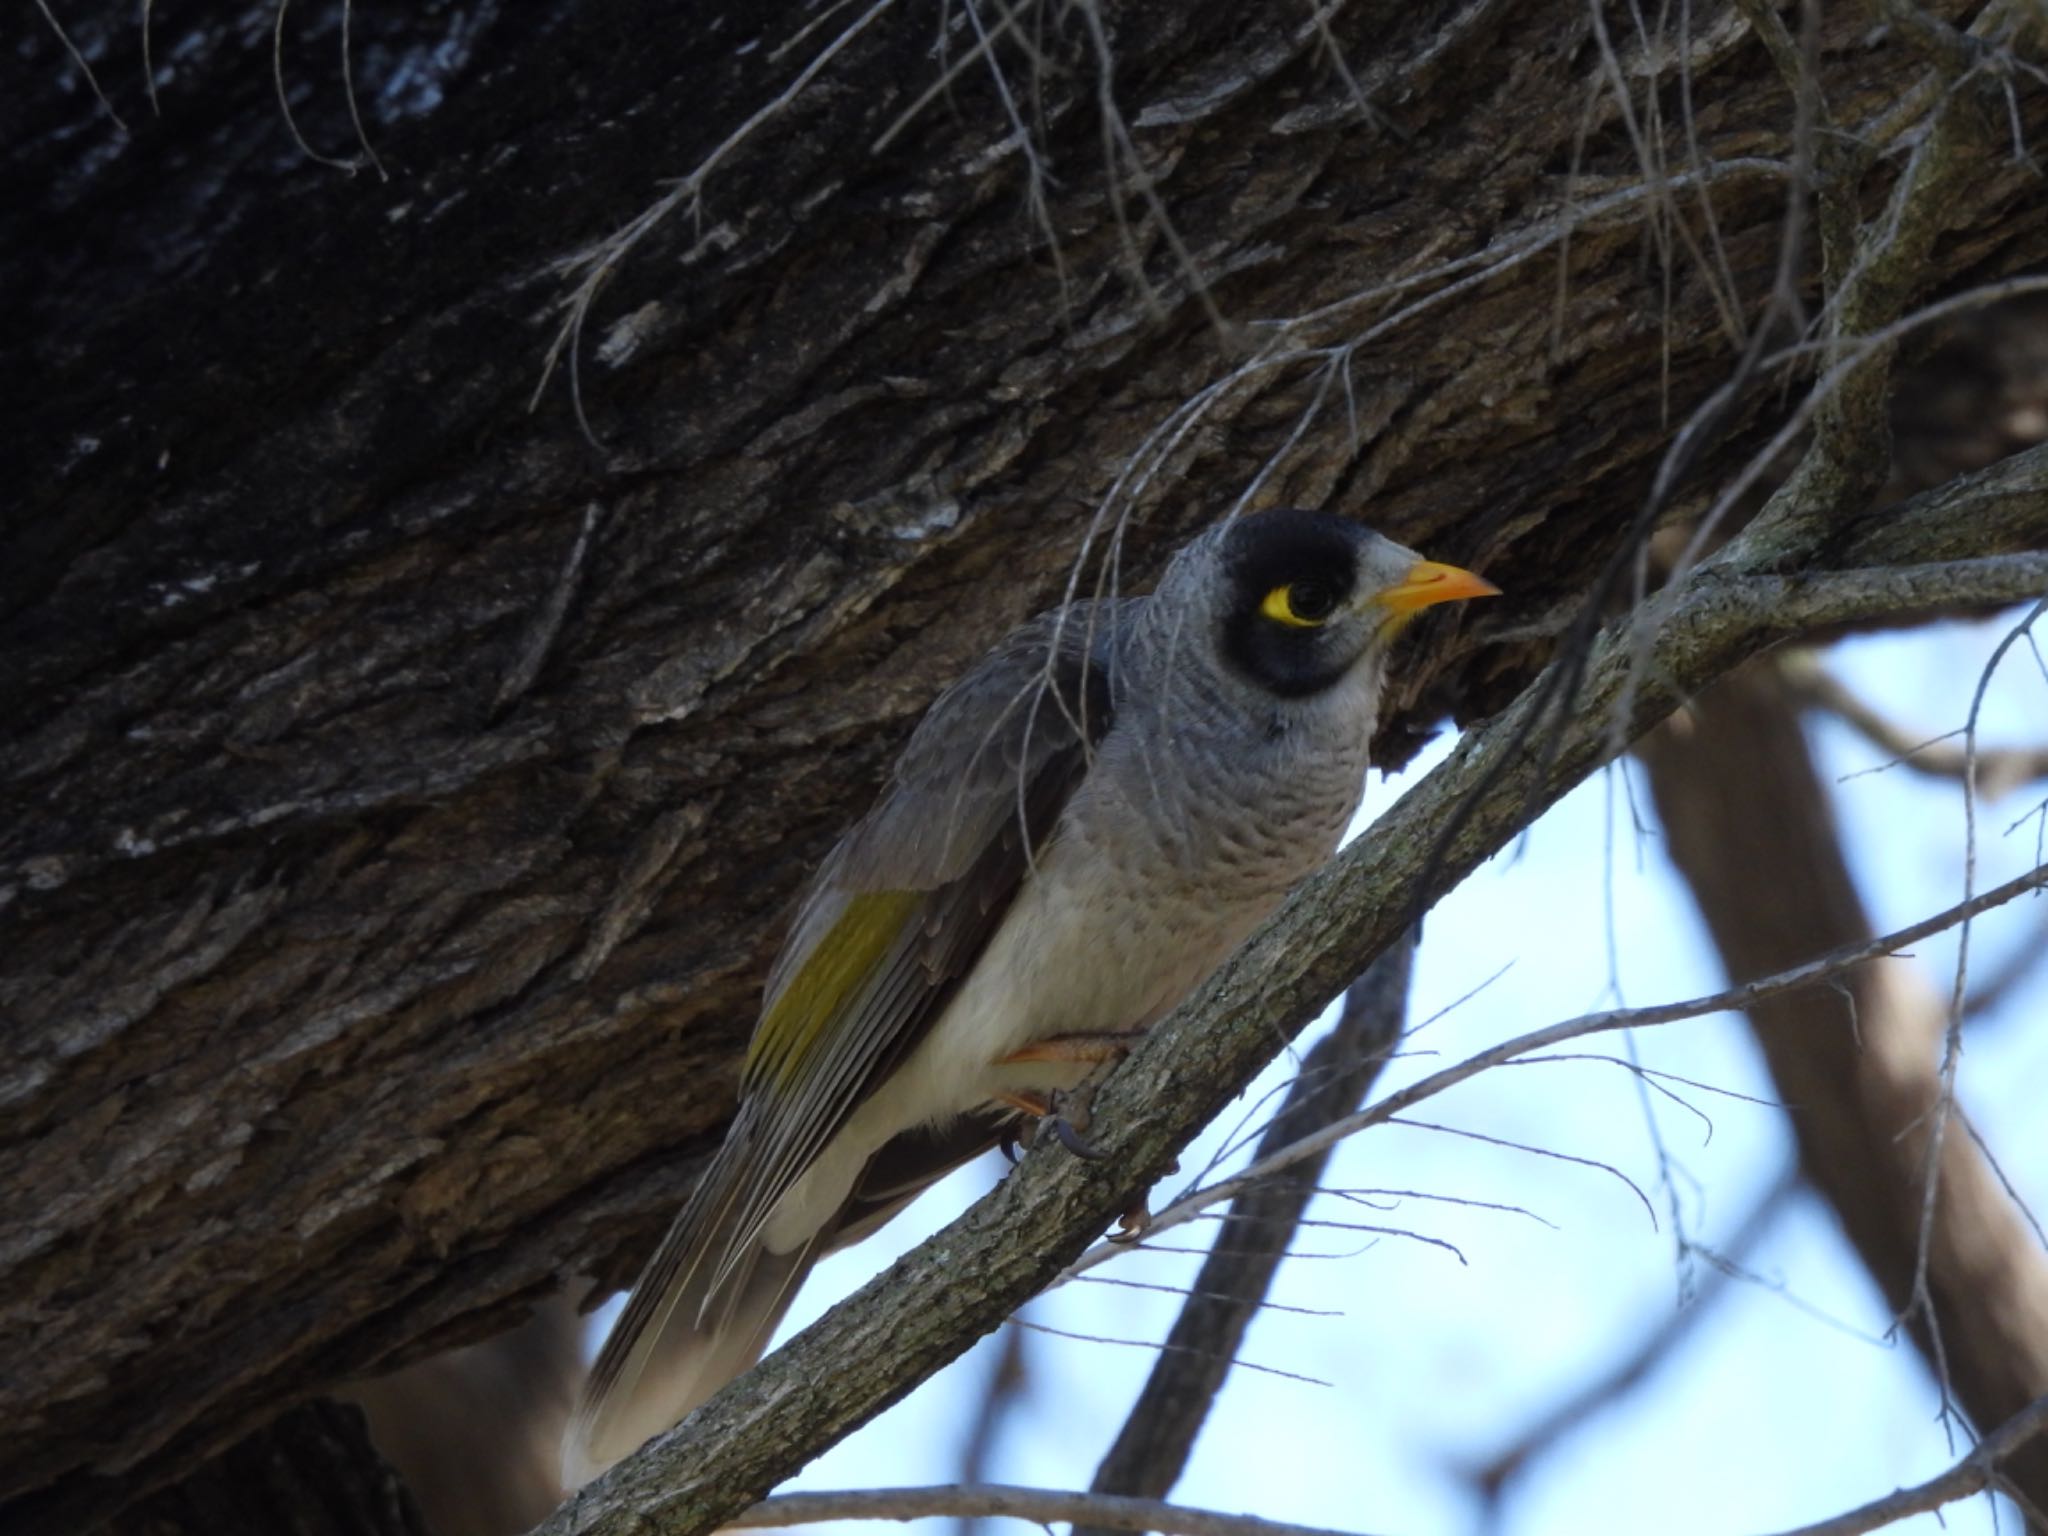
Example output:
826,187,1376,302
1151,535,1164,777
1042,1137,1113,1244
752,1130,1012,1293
1223,508,1366,698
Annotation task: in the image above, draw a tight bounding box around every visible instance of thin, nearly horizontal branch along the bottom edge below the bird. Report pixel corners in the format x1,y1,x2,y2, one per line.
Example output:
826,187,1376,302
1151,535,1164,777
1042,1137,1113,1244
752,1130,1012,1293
725,1483,1376,1536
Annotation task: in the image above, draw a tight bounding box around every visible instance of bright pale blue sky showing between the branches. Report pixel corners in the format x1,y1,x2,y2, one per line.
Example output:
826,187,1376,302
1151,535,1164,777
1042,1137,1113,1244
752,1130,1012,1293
585,612,2048,1536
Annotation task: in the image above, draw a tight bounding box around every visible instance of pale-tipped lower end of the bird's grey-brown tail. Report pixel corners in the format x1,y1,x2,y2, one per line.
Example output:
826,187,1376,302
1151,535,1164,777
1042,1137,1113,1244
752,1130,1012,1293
561,1233,819,1489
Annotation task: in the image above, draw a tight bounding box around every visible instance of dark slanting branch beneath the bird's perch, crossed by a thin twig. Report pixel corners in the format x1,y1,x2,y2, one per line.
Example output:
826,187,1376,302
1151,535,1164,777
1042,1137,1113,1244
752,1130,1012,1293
1075,934,1415,1536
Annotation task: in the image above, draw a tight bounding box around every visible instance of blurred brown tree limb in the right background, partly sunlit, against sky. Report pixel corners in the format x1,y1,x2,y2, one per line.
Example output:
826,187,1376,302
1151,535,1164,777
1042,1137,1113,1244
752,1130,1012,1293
1640,666,2048,1509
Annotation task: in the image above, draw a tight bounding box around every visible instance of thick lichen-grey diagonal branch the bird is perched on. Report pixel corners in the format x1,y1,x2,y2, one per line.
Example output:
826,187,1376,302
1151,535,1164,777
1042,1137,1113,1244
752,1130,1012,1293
543,438,2048,1536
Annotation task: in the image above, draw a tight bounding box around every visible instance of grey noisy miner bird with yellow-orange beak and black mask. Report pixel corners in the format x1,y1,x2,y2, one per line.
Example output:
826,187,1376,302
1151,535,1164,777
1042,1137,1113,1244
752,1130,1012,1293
563,510,1497,1487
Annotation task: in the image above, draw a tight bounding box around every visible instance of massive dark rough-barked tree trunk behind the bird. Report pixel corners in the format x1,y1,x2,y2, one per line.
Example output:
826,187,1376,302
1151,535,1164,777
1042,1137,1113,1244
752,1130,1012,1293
0,0,2048,1528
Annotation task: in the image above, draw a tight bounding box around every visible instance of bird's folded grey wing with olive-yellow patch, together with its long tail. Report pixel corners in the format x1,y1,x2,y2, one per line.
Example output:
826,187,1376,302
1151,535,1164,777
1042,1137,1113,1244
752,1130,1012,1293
569,602,1130,1464
